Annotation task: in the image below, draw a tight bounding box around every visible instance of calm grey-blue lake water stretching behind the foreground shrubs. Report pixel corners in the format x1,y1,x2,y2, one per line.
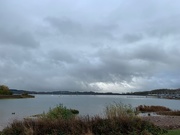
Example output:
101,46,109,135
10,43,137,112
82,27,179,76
0,95,180,126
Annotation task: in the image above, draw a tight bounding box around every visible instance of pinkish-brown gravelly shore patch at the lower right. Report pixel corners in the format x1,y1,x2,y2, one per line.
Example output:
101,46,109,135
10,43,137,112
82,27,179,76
141,116,180,129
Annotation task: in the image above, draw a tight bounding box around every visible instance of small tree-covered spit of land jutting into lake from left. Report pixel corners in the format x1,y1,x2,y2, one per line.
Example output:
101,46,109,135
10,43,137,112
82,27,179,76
0,85,35,99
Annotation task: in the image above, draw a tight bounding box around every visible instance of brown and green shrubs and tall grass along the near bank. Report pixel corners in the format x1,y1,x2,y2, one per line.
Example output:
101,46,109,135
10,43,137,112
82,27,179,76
0,104,167,135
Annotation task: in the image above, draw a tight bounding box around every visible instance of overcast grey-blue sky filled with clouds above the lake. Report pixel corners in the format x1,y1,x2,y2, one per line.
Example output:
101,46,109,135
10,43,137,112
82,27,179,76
0,0,180,93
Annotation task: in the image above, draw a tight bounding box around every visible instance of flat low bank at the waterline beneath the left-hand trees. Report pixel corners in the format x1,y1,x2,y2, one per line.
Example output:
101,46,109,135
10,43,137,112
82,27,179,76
0,95,35,99
